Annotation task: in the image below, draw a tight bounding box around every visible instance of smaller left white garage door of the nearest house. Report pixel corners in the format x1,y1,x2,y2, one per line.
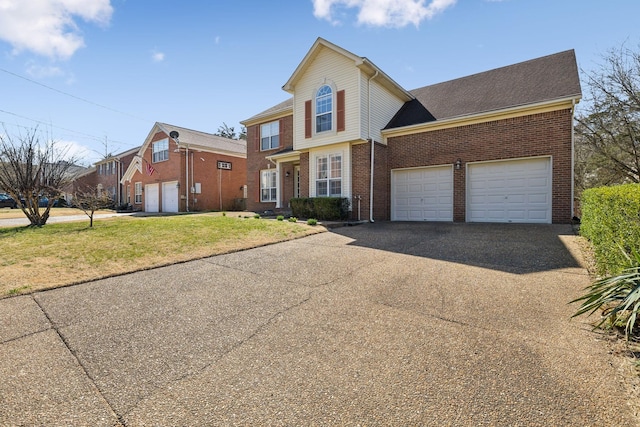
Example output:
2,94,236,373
391,166,453,221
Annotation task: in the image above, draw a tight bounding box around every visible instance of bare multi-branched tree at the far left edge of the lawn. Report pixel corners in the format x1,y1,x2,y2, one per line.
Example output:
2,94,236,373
0,129,76,227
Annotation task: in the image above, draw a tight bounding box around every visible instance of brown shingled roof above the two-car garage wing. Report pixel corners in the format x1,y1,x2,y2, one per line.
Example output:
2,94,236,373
385,50,582,129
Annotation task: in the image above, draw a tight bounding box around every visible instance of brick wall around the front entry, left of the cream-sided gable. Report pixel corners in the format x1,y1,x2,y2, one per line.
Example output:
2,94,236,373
247,115,294,212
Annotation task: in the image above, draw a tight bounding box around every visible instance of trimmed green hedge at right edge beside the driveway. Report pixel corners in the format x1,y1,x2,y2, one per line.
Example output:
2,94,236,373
580,184,640,274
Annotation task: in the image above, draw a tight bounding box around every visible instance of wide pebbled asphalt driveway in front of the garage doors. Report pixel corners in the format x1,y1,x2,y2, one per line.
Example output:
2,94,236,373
0,223,638,426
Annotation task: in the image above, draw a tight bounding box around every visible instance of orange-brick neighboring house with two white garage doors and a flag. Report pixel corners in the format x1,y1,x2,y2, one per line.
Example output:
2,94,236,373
121,123,247,212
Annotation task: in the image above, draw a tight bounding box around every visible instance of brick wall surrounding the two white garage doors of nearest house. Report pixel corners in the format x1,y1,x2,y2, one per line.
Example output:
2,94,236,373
383,109,572,223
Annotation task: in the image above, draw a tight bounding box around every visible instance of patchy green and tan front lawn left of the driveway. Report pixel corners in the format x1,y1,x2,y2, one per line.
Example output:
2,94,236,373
0,213,323,298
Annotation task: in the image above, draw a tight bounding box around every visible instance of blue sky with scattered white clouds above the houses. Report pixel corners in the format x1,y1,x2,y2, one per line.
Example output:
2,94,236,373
0,0,640,165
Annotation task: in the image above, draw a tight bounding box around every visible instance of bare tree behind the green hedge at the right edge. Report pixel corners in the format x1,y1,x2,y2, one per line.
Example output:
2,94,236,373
576,45,640,188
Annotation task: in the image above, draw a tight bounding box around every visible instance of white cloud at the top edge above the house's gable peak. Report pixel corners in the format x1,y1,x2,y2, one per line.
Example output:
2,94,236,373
313,0,457,28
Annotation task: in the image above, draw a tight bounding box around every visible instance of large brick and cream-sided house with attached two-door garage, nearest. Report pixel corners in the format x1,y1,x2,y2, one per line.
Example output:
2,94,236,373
242,38,581,223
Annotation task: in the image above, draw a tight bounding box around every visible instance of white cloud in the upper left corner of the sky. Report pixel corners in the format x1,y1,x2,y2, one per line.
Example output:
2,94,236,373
0,0,113,59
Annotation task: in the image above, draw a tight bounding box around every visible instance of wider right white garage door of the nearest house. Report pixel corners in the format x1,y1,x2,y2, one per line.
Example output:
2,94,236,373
467,157,551,224
